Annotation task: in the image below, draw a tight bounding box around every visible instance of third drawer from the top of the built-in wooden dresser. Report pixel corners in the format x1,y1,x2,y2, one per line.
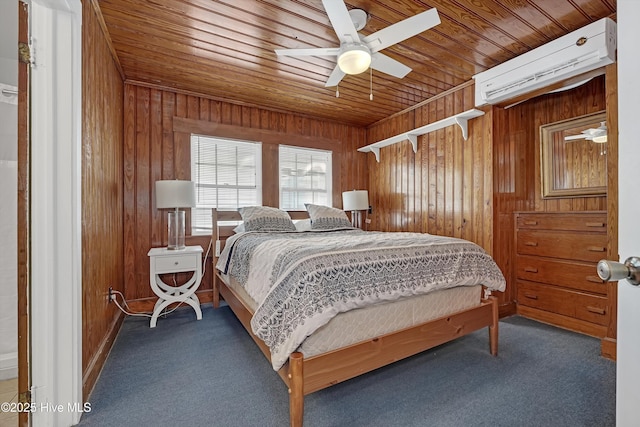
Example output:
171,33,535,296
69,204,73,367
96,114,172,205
516,255,607,295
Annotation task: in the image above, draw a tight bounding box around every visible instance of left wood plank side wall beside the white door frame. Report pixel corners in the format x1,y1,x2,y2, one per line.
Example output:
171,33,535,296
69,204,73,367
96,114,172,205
82,1,124,400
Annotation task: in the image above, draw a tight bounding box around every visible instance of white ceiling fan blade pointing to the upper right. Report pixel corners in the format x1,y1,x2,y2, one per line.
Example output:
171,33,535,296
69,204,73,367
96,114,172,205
362,8,440,52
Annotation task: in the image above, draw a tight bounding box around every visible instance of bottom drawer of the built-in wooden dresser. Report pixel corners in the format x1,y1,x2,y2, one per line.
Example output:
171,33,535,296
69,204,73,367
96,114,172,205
518,280,608,326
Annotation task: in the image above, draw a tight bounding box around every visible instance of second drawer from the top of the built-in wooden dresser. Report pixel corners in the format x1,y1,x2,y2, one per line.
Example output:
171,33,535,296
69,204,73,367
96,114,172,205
516,230,607,262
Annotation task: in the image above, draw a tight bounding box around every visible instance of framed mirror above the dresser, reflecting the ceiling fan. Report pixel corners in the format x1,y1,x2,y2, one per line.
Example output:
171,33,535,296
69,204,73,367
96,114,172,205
540,111,607,198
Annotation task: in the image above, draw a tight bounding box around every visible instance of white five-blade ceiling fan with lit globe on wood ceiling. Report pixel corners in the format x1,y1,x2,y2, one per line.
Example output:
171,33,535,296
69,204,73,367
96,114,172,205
276,0,440,87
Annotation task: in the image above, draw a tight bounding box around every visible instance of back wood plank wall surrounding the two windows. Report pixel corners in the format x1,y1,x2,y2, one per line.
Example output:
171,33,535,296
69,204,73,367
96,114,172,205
124,84,368,304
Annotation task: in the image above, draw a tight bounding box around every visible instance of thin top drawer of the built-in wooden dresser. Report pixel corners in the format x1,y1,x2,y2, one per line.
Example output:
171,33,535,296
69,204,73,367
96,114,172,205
516,212,607,234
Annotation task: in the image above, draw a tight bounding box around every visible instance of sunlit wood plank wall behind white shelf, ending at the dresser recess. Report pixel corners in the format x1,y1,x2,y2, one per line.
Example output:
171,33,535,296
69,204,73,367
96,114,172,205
367,84,494,304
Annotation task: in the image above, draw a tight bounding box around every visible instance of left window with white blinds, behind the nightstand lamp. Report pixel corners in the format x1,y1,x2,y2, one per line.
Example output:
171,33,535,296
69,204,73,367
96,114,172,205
191,135,262,234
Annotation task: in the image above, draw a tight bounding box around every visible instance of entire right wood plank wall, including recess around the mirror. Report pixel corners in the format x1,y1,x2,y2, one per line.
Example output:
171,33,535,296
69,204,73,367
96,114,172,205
367,78,607,315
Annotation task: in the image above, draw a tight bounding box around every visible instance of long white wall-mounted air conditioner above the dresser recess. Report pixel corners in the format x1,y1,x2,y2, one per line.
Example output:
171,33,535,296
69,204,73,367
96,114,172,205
473,18,616,107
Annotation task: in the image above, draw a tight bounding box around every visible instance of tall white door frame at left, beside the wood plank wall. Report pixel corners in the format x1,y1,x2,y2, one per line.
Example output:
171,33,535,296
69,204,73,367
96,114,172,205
18,0,84,425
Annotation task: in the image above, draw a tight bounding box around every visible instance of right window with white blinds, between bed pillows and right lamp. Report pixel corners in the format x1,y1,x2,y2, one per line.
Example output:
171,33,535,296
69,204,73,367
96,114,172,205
279,145,331,210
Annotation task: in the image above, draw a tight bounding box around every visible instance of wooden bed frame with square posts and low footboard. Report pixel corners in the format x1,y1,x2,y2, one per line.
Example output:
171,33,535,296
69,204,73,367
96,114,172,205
212,209,498,427
